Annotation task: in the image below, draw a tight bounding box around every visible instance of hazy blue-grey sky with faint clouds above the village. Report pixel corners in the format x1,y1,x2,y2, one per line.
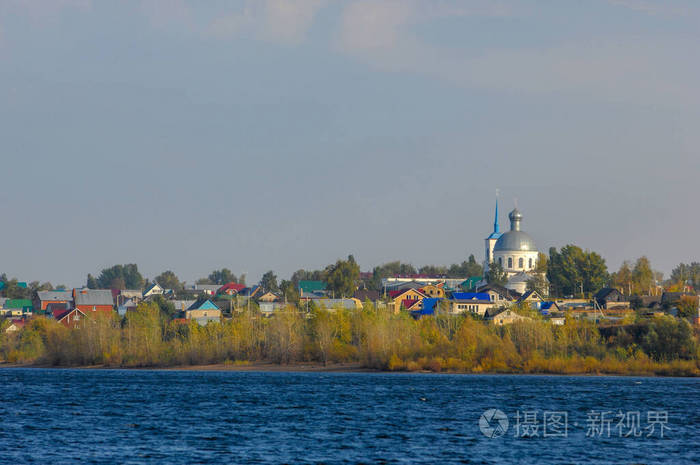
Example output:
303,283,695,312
0,0,700,286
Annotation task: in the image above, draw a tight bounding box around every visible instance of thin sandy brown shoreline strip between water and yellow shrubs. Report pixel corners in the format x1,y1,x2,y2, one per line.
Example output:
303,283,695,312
0,362,697,378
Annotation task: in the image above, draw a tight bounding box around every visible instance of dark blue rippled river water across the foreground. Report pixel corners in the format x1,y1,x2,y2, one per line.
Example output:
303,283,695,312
0,369,700,465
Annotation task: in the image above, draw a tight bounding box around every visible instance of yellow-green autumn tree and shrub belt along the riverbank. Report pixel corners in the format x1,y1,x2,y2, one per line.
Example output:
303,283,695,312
0,302,700,376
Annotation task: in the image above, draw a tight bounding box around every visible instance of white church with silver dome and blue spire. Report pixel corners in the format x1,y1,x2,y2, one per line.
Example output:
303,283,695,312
484,200,539,294
